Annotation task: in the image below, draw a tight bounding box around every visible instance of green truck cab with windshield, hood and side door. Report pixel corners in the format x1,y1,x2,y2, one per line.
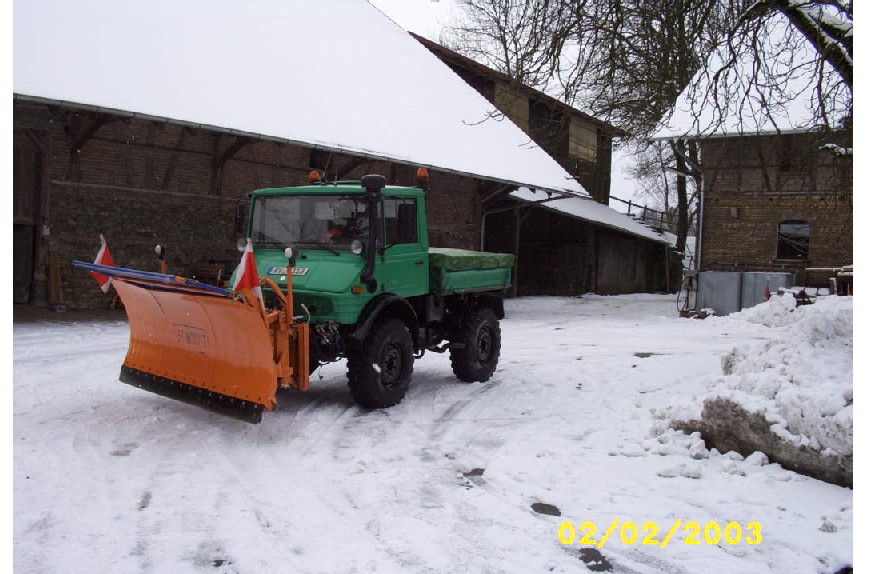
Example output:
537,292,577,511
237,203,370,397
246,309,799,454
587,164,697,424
249,181,429,325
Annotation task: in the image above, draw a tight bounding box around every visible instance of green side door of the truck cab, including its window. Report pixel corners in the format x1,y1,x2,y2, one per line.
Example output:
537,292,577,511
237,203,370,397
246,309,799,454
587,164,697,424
375,196,429,297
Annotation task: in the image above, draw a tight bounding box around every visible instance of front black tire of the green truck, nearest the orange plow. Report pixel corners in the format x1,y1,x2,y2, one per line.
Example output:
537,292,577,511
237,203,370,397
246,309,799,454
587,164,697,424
347,319,414,409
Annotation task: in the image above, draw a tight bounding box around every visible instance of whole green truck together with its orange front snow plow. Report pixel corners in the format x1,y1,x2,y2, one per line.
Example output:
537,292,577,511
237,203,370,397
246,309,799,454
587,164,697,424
73,174,514,423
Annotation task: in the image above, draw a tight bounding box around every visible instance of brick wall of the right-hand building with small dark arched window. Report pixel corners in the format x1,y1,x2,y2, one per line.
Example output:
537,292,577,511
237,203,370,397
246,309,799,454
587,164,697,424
699,131,852,281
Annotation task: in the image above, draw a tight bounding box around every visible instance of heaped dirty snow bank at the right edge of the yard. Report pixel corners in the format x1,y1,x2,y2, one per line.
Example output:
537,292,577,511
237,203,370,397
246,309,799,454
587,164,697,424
673,295,853,485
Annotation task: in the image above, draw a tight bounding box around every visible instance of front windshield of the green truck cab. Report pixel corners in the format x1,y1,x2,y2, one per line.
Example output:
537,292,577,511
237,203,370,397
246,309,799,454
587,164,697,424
250,195,368,250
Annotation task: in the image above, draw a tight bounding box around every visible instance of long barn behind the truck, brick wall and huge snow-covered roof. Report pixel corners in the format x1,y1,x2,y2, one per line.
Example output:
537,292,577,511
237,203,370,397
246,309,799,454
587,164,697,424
13,0,672,308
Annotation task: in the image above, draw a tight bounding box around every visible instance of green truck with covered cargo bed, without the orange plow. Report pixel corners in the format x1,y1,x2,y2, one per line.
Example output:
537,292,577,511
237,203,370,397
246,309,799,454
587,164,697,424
248,175,514,408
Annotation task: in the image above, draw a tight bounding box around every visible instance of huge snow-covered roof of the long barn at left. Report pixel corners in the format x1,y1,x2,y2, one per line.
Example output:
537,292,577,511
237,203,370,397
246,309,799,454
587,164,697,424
13,0,586,194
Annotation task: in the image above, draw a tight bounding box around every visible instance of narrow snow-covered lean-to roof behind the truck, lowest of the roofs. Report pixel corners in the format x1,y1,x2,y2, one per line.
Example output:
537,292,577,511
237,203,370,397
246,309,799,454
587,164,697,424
511,188,675,245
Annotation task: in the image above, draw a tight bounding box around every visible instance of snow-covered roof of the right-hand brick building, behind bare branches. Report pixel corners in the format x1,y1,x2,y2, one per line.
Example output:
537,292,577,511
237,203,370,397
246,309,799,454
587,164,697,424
683,0,852,137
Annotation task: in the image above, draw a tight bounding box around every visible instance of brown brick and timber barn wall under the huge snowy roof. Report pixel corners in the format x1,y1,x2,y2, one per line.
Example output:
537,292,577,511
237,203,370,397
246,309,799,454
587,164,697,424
13,101,481,308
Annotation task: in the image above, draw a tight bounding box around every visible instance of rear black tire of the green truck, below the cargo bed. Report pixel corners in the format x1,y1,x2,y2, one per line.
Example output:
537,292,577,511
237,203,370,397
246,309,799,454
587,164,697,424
450,307,502,383
